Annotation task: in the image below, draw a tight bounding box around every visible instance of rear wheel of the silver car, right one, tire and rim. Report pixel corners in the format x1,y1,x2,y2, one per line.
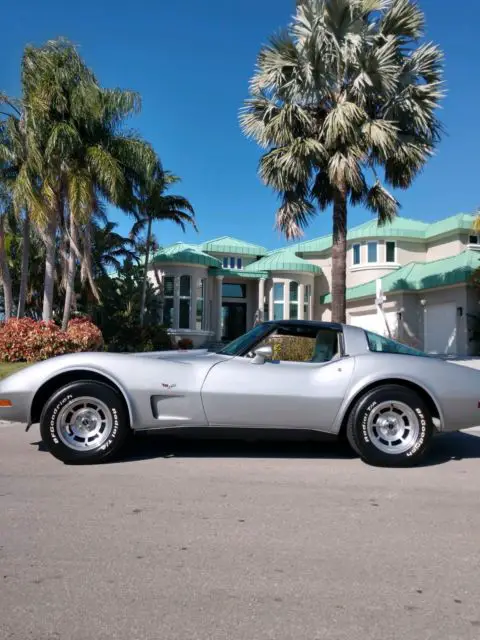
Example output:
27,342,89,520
347,385,434,467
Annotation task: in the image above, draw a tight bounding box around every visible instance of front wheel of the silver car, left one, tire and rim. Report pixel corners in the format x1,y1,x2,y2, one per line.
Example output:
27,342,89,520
40,381,130,464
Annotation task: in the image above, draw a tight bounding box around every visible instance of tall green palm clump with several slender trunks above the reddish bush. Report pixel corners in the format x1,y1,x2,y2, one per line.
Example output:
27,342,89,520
22,40,156,327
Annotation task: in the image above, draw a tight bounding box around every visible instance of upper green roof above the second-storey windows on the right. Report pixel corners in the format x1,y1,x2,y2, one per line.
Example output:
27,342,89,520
294,213,475,253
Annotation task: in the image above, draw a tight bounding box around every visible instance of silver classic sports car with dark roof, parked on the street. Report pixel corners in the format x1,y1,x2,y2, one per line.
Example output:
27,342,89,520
0,320,480,466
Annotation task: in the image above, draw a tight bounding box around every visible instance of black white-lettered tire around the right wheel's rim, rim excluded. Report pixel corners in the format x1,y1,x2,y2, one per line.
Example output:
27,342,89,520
353,387,433,466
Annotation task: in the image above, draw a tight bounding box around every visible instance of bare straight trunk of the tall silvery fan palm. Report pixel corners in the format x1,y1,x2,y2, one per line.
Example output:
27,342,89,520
332,188,347,323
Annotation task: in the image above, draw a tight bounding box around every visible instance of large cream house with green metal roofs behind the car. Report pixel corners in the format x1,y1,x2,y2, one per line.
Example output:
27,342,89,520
150,214,480,355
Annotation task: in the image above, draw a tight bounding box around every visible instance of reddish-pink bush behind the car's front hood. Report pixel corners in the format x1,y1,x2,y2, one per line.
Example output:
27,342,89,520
0,318,103,362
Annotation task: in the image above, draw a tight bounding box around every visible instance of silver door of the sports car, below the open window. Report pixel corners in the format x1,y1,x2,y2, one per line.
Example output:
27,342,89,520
202,357,355,431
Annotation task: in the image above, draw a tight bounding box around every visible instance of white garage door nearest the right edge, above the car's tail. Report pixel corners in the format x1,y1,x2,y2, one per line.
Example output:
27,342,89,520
425,302,457,353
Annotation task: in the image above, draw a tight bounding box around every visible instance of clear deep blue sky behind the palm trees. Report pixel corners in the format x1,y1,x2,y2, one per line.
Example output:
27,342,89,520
0,0,480,248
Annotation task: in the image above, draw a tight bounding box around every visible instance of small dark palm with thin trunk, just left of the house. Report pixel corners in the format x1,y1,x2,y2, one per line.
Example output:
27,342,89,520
130,169,197,326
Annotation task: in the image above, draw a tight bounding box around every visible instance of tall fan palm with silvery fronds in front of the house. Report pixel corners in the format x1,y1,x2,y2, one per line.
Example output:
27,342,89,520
240,0,443,322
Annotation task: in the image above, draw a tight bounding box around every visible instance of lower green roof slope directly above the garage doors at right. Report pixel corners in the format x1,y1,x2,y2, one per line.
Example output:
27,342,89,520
320,249,480,304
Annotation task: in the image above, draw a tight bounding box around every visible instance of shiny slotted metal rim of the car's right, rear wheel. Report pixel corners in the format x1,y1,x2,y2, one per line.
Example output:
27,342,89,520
367,401,420,454
